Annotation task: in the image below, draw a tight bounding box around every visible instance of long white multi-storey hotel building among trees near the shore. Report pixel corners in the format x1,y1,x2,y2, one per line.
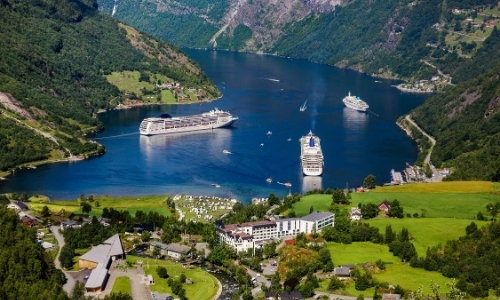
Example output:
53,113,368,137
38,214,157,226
217,212,335,252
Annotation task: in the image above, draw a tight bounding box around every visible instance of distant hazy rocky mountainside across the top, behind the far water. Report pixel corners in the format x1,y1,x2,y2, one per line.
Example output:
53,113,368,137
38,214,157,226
98,0,500,84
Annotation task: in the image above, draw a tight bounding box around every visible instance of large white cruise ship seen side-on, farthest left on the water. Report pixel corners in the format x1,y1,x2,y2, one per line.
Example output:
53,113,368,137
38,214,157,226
139,108,238,135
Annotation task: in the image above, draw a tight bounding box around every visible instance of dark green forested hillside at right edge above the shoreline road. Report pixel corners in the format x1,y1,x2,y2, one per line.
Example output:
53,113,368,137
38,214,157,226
411,64,500,181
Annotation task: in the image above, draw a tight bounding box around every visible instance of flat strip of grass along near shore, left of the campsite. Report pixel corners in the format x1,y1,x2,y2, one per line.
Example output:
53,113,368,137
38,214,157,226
30,196,170,216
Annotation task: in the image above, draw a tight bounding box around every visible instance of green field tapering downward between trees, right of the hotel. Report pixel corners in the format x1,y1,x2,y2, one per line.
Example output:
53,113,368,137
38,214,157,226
366,218,478,256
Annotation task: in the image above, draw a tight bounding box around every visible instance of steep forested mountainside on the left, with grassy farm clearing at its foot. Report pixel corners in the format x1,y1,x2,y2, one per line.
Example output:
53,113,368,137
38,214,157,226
0,0,221,176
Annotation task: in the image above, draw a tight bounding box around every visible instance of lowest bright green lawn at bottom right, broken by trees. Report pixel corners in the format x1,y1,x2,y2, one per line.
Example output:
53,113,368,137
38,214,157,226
322,242,451,297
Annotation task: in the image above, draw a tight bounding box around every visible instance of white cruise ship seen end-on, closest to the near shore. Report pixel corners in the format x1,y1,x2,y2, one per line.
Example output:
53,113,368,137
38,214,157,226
300,131,324,176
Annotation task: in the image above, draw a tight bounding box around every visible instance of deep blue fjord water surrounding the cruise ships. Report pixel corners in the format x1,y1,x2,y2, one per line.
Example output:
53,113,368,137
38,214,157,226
0,50,429,203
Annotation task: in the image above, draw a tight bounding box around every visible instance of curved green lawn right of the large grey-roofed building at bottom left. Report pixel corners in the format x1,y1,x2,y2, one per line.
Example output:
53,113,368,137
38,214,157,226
127,255,219,300
